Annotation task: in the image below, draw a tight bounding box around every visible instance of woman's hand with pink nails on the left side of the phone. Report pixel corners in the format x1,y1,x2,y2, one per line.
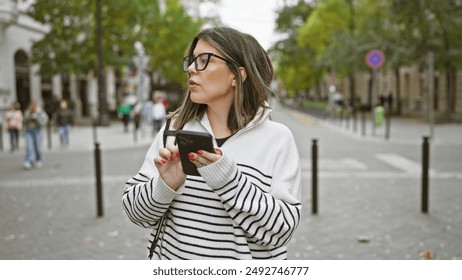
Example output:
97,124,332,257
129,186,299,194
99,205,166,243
154,144,186,190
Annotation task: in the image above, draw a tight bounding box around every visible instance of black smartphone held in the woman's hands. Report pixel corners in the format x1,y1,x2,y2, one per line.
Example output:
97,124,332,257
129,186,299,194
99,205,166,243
176,130,214,176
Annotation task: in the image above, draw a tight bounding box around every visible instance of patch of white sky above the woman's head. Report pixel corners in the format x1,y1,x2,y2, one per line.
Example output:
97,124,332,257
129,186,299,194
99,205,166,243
201,0,283,49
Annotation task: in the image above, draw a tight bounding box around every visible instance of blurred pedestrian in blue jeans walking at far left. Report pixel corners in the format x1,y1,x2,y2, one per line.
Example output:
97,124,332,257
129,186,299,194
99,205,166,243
24,101,48,170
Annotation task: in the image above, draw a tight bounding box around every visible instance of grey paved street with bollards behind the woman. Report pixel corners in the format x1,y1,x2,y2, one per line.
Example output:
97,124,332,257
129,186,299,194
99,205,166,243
0,104,462,260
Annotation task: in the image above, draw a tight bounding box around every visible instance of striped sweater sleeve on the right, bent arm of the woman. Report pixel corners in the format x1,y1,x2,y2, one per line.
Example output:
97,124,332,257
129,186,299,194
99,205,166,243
200,132,302,247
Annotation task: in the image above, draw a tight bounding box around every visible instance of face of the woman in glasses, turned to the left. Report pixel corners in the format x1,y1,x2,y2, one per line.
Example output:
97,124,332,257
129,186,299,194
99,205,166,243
188,39,235,108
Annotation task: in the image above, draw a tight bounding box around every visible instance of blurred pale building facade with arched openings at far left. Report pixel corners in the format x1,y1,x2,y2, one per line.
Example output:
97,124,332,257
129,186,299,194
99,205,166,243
0,0,117,122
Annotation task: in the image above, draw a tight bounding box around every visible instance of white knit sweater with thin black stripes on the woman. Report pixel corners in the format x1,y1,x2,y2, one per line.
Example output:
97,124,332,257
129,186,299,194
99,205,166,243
123,106,301,260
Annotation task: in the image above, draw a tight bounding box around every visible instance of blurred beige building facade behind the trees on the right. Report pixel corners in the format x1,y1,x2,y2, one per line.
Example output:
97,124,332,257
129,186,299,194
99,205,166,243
306,66,462,122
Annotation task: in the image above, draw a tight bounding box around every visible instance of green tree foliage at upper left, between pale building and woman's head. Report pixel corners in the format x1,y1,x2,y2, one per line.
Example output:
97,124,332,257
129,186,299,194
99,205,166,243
29,0,202,86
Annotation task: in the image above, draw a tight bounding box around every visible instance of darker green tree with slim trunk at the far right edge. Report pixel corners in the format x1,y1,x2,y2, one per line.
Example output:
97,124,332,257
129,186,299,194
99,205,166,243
391,0,462,120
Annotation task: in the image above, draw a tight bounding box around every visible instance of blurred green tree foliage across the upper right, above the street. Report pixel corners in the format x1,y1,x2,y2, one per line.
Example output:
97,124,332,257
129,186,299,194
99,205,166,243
271,0,462,99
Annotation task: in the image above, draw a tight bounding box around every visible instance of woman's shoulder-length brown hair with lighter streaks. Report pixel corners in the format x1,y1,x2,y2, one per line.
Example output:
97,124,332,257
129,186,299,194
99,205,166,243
167,27,274,132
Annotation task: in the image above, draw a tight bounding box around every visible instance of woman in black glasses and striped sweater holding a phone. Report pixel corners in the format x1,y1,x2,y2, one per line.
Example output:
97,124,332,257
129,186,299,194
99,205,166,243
123,27,301,259
